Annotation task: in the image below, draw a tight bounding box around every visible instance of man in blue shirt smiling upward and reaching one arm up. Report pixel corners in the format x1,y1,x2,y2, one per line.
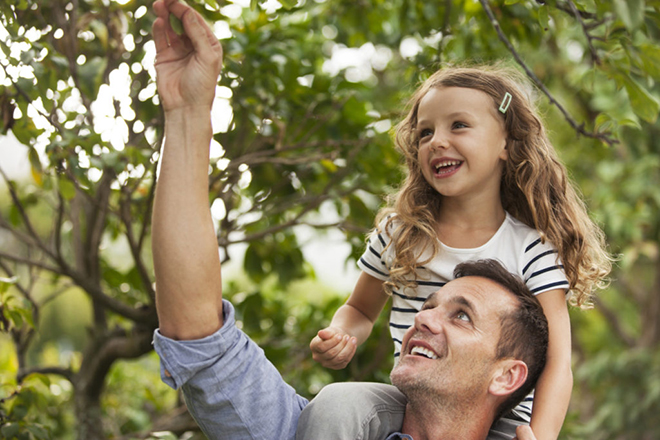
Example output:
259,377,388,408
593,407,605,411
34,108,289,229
153,0,547,440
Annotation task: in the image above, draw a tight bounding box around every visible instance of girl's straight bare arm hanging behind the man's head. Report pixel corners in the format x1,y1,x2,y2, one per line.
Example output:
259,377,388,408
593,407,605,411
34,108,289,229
531,289,573,440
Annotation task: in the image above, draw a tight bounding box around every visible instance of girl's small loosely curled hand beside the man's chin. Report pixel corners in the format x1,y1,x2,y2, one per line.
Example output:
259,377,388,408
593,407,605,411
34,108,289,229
309,327,357,370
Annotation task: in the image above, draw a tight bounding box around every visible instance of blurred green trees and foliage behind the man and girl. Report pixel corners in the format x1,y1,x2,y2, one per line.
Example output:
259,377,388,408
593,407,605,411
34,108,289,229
0,0,660,440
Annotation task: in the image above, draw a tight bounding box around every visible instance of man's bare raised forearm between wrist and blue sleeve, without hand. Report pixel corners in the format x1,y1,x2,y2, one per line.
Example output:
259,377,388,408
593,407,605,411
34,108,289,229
153,106,222,339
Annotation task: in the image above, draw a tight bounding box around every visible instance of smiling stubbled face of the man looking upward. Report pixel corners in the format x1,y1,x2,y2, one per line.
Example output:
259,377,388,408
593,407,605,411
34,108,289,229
391,277,516,402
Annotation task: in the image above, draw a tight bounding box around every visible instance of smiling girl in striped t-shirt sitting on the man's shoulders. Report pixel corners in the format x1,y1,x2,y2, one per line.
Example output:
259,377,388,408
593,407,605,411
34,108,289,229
310,66,611,439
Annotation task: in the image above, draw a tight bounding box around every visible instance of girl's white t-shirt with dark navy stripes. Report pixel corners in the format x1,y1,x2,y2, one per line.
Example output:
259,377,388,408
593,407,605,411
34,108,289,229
358,213,569,422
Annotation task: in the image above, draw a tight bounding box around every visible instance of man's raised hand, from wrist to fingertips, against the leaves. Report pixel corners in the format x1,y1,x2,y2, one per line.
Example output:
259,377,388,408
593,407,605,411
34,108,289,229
153,0,222,112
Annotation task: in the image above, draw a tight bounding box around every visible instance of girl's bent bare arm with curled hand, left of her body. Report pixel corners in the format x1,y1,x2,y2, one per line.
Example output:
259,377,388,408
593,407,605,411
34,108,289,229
309,272,389,370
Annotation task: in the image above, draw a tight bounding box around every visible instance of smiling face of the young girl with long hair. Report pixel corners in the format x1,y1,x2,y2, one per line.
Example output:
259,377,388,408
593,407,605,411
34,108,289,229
416,87,507,201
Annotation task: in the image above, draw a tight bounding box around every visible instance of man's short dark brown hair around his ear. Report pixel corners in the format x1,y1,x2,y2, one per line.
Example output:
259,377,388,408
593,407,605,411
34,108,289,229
454,259,548,420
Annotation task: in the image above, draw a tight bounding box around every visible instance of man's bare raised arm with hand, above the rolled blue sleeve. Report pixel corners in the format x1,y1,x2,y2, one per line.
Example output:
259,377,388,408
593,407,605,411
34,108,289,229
152,0,223,339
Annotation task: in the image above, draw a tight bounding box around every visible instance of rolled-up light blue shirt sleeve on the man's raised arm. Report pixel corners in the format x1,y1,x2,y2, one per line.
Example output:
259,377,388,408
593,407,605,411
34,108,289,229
154,301,308,440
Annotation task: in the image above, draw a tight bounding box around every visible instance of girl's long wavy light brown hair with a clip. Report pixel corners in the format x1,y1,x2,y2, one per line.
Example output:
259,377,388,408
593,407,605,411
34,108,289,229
376,66,612,308
